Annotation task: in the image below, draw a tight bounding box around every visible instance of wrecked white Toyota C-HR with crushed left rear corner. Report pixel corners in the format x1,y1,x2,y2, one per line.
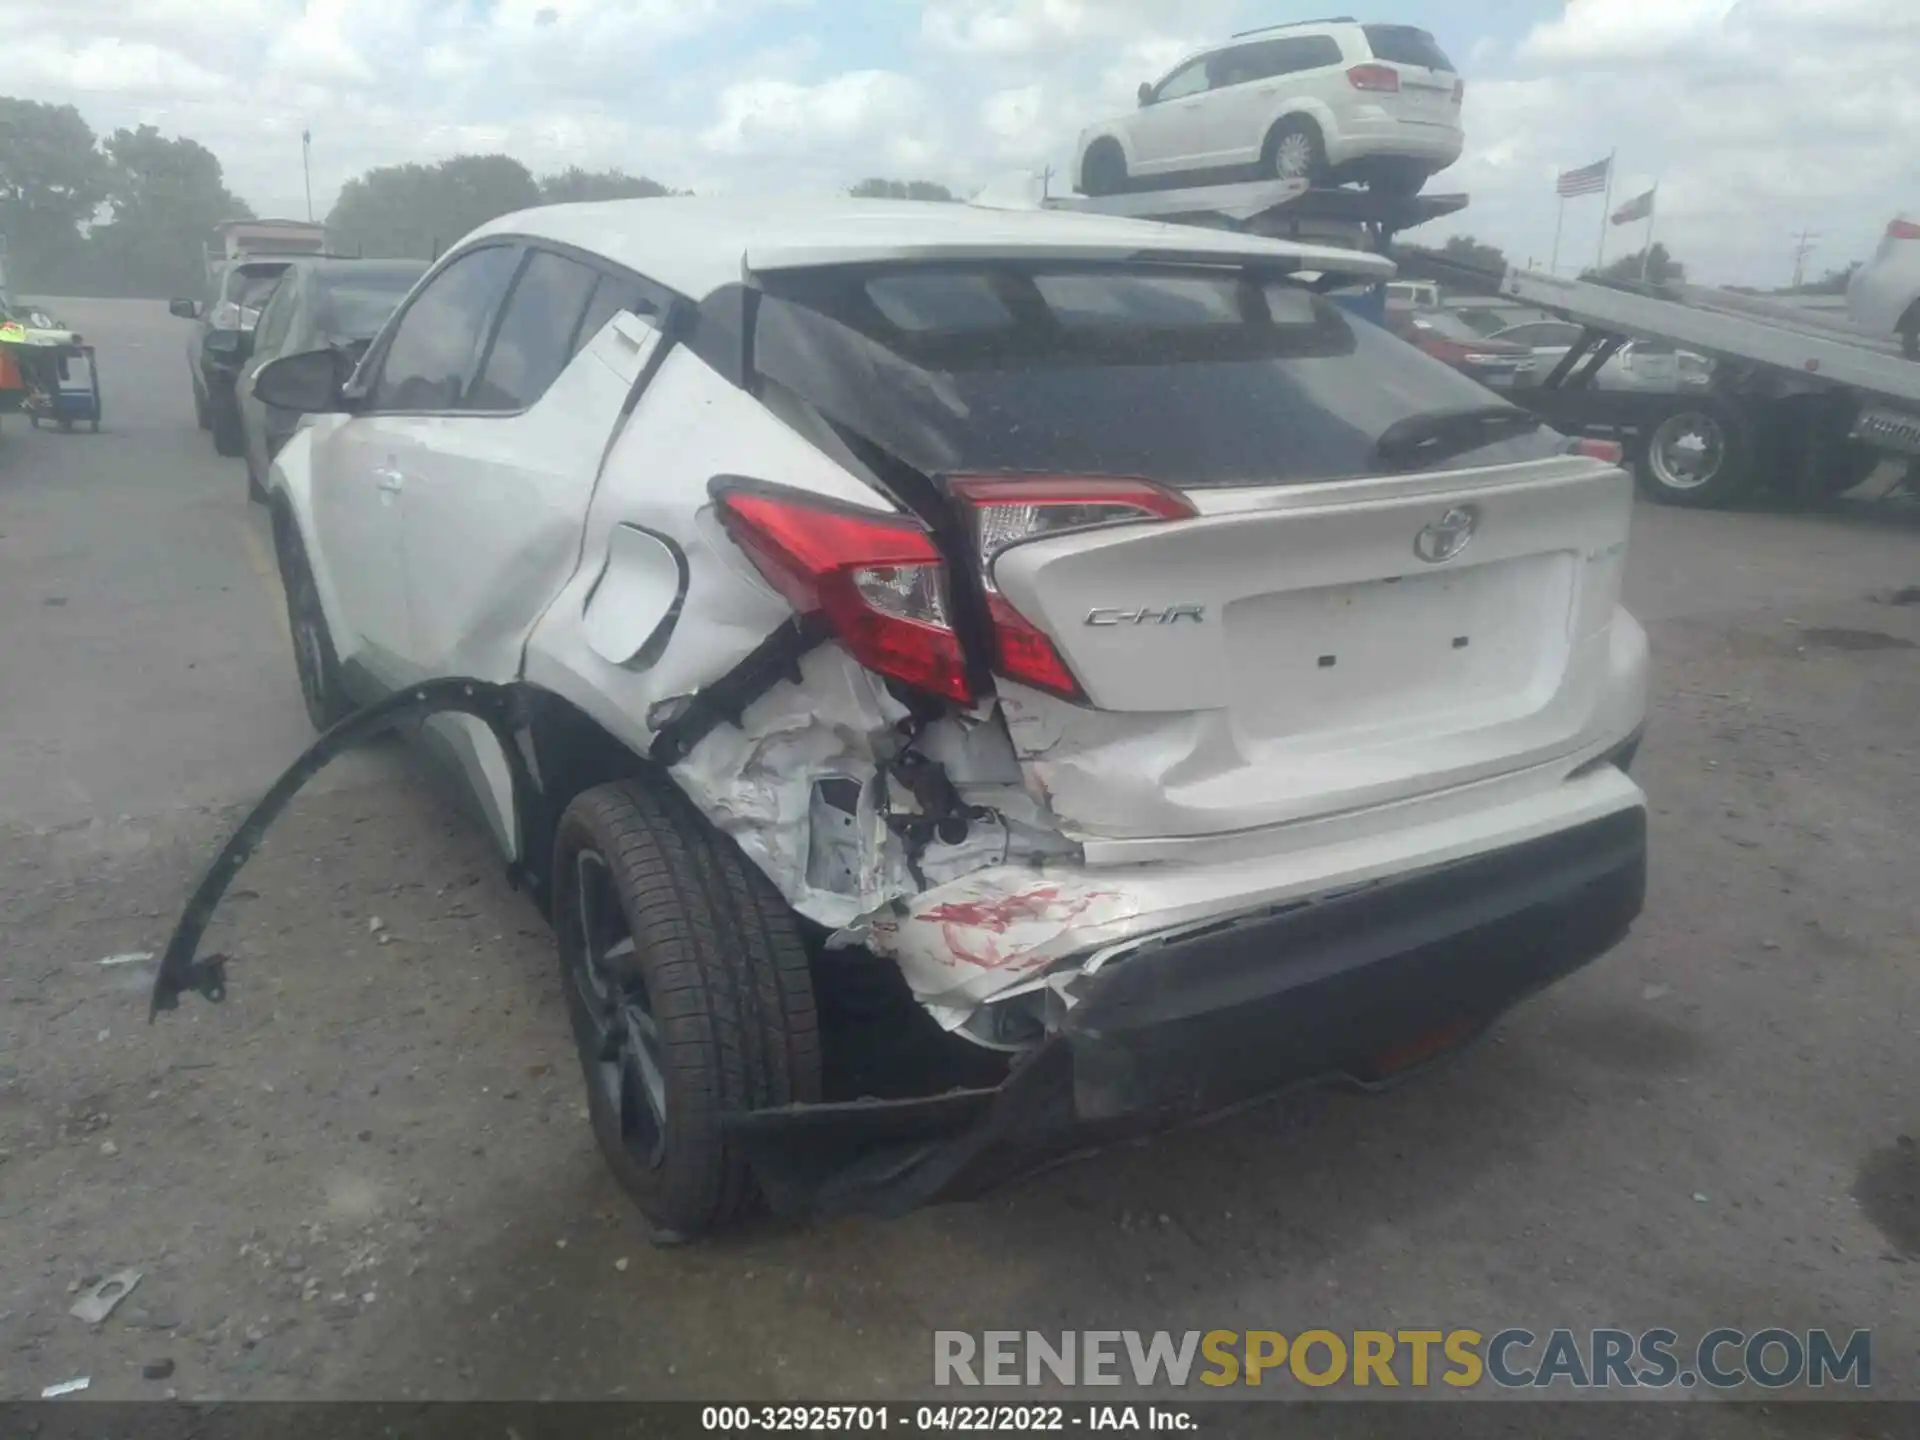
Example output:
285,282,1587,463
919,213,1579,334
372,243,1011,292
156,198,1647,1238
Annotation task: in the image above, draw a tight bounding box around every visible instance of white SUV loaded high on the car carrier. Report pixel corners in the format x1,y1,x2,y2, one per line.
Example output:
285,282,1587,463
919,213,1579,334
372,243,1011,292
1073,19,1467,196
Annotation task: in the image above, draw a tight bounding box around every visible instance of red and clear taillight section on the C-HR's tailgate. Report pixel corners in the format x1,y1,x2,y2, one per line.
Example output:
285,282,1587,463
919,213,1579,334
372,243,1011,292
952,476,1194,701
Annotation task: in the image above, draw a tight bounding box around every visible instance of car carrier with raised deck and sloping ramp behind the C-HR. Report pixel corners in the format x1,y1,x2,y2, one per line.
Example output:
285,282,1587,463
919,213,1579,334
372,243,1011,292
975,180,1920,507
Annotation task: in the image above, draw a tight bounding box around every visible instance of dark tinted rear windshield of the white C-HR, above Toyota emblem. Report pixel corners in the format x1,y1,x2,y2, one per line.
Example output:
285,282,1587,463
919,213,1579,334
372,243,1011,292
748,265,1561,488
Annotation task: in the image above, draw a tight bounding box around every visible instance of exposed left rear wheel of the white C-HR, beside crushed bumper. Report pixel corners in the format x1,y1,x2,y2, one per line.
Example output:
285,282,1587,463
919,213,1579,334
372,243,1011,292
553,780,820,1244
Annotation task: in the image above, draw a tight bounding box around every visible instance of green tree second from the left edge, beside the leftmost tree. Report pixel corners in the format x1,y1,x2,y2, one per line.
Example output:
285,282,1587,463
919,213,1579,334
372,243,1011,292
88,125,253,296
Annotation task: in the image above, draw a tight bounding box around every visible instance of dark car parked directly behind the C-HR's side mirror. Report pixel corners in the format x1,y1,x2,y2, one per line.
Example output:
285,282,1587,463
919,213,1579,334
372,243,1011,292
234,259,426,499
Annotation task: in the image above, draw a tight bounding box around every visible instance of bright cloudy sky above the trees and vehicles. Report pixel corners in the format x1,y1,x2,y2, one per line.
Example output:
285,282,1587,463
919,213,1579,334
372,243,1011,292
0,0,1920,284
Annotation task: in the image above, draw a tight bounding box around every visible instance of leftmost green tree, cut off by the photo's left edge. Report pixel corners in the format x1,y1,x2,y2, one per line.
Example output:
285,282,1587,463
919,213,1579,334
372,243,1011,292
0,96,108,290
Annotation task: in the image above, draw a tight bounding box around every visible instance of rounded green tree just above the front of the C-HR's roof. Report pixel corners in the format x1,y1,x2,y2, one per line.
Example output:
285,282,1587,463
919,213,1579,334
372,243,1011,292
326,156,541,259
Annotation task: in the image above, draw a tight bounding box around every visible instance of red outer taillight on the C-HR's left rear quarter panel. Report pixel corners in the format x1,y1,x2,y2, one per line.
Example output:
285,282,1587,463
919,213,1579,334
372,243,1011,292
716,490,973,703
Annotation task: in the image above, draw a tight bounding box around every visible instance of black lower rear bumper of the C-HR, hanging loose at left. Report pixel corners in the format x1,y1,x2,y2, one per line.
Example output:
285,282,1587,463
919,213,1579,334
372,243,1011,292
730,806,1645,1213
